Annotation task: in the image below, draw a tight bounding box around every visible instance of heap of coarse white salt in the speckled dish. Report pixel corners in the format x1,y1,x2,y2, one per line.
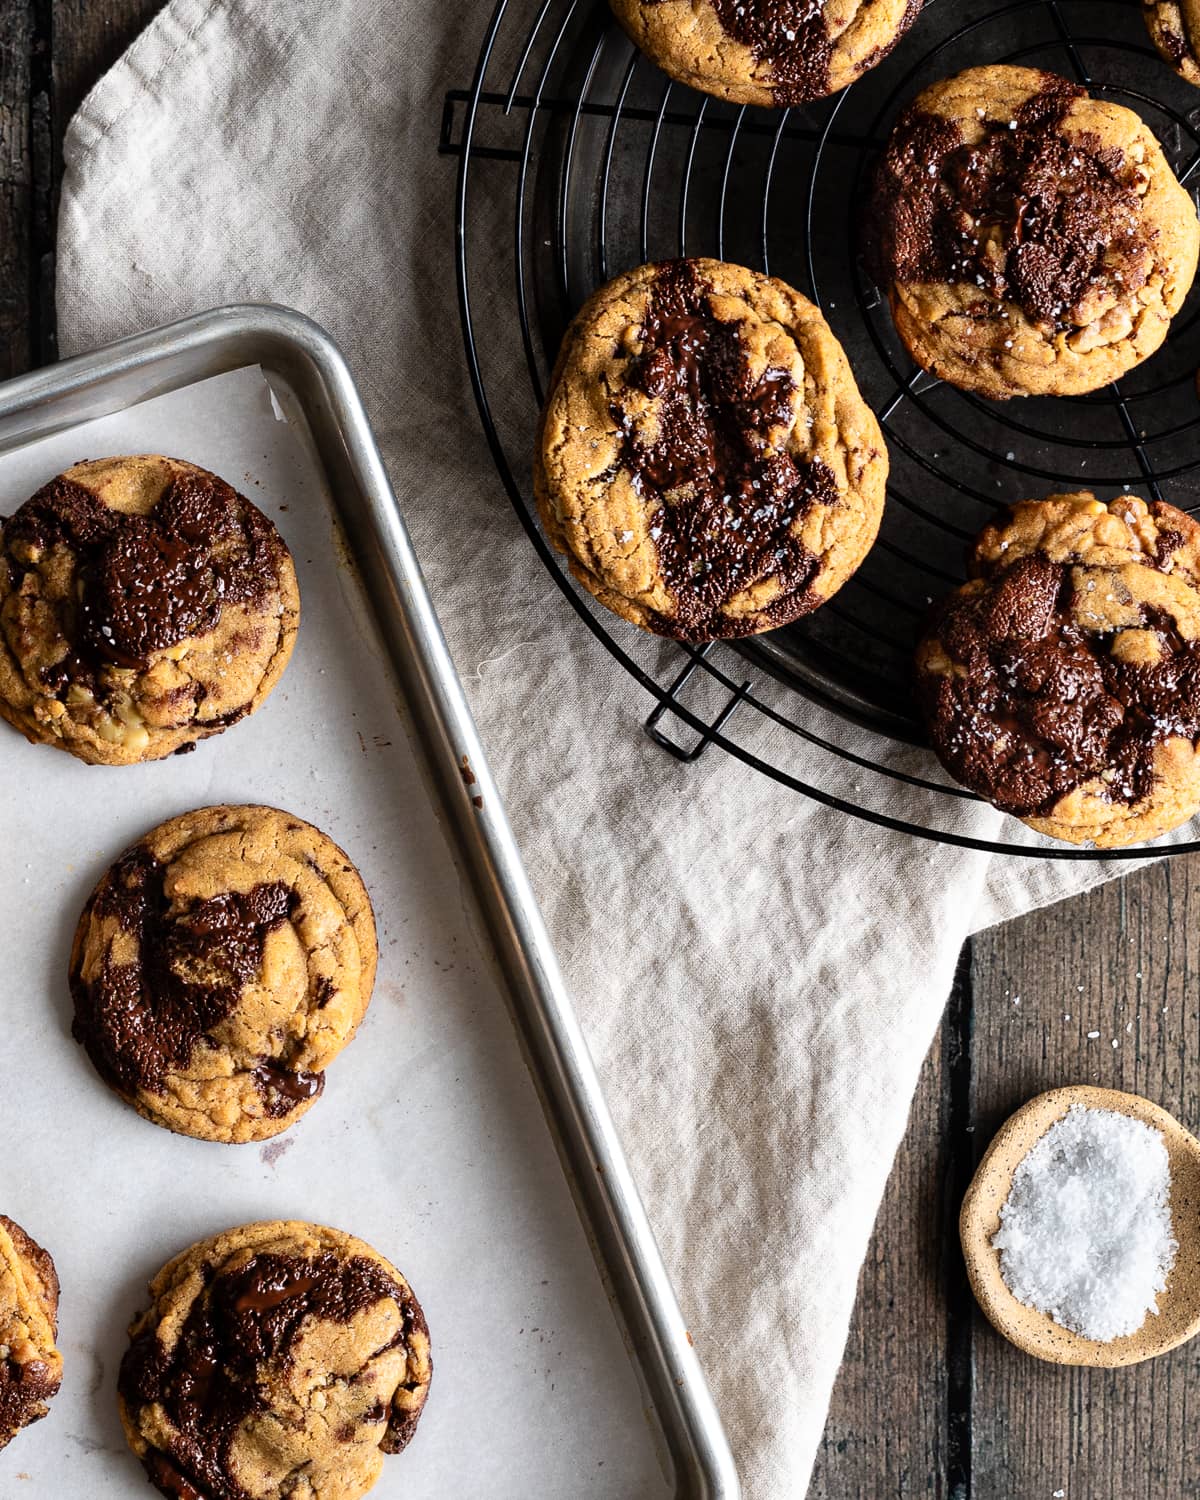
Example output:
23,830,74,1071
992,1104,1179,1343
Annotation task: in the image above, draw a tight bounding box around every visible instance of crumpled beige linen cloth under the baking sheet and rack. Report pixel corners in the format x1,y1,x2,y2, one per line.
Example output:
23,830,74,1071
59,0,1134,1500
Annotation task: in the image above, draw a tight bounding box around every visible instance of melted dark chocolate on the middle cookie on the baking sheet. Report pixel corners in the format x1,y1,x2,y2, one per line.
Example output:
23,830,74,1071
71,848,300,1115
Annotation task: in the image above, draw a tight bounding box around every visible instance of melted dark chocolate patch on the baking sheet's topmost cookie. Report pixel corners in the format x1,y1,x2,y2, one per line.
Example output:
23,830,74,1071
3,474,284,693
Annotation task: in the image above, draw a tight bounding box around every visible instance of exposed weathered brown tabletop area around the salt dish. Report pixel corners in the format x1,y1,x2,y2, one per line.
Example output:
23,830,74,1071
812,858,1200,1500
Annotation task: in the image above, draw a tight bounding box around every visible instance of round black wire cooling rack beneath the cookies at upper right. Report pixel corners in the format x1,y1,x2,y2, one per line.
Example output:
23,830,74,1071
441,0,1200,860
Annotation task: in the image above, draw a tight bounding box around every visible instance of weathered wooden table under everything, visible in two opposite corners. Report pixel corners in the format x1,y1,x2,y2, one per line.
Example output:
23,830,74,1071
0,0,1200,1500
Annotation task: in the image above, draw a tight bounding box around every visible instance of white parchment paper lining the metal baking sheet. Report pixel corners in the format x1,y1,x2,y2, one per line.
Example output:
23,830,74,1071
0,371,671,1500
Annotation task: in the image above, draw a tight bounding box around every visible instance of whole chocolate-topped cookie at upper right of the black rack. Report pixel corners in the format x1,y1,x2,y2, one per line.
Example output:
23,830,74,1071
867,66,1200,399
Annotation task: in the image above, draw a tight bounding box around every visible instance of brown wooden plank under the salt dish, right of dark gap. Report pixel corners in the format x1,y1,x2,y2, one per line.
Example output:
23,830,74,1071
971,858,1200,1500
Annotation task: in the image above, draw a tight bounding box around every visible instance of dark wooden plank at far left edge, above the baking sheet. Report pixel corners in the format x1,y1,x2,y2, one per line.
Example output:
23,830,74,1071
0,0,35,380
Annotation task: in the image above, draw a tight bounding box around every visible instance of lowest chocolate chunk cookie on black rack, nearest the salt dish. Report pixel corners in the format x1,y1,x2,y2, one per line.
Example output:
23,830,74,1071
917,494,1200,848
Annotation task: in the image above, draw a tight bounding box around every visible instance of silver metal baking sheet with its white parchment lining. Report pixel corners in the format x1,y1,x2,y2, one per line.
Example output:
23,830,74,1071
0,308,738,1500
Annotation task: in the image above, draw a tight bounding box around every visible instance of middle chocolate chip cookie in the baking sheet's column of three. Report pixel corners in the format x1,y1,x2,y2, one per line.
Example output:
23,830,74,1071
71,807,378,1142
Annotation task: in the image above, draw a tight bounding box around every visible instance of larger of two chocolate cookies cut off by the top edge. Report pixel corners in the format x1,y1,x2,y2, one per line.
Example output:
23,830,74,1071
612,0,921,107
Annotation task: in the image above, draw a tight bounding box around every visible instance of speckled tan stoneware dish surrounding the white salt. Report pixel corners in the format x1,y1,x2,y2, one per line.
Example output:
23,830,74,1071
959,1085,1200,1367
